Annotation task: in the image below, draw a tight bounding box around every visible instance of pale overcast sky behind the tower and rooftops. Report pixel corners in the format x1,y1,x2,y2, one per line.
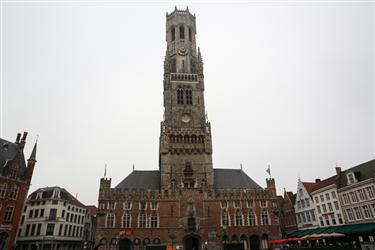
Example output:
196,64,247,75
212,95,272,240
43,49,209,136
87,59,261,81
0,0,375,204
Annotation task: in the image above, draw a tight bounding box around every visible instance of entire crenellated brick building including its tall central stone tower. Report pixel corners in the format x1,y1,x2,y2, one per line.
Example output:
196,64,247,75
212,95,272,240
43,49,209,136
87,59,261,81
97,9,280,250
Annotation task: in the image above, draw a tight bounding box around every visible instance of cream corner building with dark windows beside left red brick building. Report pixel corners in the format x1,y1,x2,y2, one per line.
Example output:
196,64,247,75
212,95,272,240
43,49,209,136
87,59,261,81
17,187,89,250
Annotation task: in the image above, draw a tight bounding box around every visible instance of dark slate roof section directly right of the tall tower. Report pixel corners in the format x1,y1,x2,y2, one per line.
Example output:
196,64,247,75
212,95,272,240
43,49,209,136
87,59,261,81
214,168,262,189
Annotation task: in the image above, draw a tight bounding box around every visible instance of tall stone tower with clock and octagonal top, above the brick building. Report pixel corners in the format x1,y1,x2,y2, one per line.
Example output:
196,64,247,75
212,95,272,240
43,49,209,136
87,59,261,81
159,8,214,190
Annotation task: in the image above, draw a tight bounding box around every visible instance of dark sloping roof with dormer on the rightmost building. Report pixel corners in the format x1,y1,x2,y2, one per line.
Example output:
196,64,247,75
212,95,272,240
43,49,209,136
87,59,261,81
337,159,375,188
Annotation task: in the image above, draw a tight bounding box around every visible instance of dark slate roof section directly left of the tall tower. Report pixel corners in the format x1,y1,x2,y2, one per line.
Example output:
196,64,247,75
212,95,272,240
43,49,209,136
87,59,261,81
115,170,160,189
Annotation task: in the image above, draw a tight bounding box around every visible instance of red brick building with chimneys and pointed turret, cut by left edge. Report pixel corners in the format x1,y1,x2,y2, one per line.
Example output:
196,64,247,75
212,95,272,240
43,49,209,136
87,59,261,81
0,132,37,250
